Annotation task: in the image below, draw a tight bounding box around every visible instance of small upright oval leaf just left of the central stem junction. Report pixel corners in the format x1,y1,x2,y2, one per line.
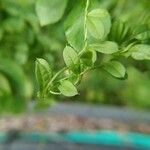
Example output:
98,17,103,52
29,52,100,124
63,46,79,70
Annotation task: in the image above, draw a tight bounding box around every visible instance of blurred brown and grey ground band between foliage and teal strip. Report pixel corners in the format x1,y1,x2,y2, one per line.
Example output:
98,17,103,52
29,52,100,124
0,104,150,133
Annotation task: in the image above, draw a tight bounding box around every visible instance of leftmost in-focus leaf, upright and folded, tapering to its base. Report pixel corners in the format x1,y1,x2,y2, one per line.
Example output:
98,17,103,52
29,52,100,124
35,58,52,95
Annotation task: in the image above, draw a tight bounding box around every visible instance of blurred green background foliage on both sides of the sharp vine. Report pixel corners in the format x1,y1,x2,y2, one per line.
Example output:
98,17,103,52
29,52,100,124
0,0,150,112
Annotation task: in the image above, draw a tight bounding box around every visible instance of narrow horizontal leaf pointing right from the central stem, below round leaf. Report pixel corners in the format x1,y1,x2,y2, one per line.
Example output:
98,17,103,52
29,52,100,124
90,41,119,54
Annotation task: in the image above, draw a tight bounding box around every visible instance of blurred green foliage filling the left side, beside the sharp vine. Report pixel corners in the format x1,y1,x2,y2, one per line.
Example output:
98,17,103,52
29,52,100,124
0,0,65,112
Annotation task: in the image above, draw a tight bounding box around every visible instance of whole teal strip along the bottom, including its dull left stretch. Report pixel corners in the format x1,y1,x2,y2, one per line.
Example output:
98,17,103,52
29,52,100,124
0,130,150,150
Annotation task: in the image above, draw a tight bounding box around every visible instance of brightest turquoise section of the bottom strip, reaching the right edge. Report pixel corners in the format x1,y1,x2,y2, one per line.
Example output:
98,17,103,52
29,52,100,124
64,130,150,149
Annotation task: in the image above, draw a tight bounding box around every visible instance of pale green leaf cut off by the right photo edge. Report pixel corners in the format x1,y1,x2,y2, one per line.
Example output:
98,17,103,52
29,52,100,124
130,44,150,60
